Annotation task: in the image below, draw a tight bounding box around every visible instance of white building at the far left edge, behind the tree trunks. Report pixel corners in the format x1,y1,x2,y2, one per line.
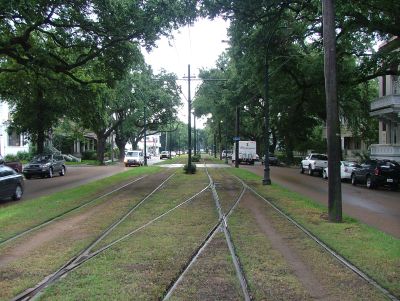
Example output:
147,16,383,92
0,102,29,157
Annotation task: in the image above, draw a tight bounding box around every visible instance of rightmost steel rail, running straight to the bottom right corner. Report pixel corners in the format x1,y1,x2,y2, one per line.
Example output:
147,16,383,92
236,177,400,301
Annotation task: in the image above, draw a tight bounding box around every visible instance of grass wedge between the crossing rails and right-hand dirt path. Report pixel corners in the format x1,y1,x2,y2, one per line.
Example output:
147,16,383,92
228,198,311,300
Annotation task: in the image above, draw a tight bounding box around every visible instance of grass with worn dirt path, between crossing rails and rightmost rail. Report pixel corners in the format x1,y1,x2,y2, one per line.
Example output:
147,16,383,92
229,192,385,300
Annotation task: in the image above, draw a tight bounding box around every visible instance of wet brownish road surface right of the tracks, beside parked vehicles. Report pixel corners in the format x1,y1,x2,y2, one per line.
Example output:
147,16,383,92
240,165,400,238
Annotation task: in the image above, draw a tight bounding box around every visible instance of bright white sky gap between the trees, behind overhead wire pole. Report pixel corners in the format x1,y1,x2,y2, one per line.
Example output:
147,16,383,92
143,19,229,128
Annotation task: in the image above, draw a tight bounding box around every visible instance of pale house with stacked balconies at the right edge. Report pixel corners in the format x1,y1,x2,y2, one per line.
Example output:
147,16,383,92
369,40,400,162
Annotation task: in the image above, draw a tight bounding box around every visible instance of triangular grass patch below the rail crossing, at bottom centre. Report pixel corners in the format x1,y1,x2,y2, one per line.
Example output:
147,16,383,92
170,232,244,301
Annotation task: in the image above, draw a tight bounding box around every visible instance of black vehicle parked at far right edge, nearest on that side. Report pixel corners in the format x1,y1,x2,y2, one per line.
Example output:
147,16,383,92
351,160,400,190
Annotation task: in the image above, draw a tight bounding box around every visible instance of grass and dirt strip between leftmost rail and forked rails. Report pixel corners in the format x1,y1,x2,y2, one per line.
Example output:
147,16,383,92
0,174,168,300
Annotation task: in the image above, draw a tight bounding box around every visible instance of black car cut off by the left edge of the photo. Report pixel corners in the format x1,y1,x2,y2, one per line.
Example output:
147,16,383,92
0,165,24,201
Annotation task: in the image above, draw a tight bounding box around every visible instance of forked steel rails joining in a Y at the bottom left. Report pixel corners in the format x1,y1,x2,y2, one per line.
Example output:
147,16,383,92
12,174,214,301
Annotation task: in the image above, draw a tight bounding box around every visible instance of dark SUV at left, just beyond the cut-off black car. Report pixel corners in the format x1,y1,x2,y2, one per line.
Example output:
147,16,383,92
23,154,67,179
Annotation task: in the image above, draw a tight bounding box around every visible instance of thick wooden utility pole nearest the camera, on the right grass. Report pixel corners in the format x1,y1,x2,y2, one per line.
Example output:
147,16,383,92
322,0,342,222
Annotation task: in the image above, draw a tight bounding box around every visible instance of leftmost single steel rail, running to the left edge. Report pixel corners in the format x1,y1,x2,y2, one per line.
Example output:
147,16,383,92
0,175,147,247
